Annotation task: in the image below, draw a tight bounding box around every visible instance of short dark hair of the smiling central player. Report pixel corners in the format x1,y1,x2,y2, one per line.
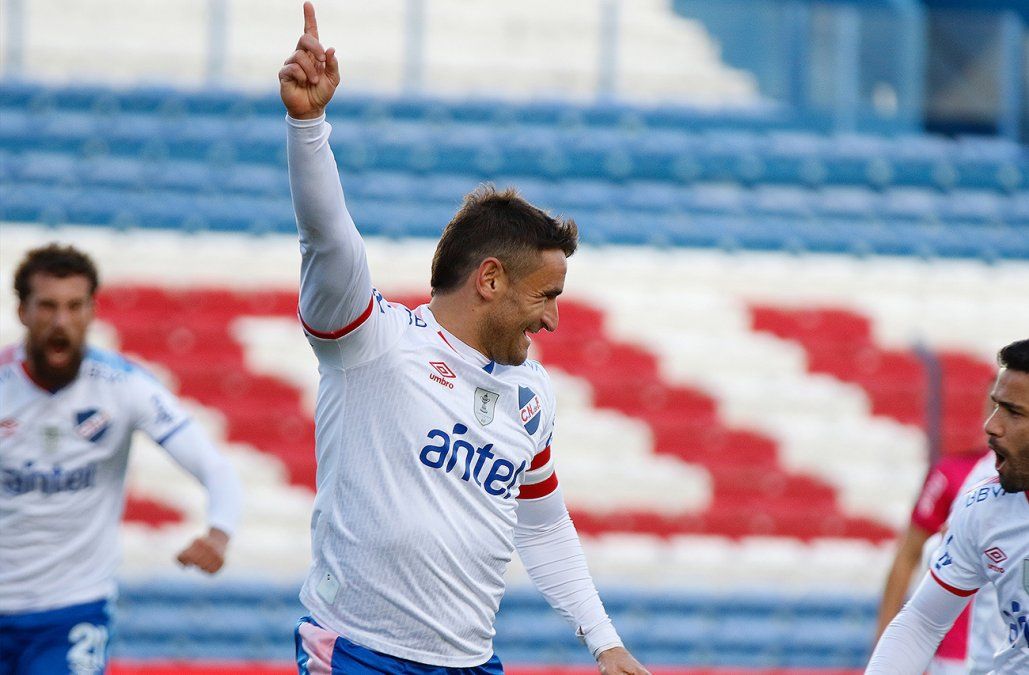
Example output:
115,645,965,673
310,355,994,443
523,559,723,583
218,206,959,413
431,184,578,295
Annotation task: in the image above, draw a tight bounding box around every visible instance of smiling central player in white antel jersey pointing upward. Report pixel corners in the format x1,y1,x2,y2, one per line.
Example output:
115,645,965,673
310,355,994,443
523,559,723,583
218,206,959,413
279,3,647,675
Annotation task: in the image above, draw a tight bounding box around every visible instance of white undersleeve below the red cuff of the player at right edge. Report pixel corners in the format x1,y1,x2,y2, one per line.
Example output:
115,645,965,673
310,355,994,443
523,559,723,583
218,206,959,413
864,574,968,675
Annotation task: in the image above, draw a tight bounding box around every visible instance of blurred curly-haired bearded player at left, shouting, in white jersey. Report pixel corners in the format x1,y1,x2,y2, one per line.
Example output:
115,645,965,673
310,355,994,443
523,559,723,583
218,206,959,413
0,244,241,675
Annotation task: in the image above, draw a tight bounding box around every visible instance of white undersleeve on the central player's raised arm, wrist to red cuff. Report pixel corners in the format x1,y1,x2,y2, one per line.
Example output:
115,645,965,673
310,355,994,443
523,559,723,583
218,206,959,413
286,115,372,339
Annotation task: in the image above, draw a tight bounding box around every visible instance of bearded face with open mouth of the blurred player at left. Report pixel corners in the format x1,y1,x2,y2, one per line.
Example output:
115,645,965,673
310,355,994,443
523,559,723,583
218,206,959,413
17,273,93,389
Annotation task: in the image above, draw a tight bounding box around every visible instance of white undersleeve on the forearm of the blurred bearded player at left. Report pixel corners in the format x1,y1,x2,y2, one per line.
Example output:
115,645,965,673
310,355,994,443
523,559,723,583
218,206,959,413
161,422,243,535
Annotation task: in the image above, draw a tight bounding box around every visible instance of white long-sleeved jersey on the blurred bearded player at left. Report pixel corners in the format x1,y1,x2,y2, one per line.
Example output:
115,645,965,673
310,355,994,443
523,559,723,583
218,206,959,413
0,346,241,614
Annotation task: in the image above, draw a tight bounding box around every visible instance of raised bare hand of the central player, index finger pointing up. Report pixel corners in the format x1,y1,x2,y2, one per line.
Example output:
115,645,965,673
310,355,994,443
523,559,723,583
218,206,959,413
279,2,340,119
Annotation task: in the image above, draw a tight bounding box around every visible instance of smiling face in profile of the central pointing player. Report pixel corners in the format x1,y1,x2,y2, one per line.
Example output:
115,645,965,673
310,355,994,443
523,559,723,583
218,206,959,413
483,249,568,365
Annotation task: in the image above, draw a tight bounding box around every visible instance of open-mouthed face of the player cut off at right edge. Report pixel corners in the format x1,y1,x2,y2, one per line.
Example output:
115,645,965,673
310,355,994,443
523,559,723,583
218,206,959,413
984,368,1029,492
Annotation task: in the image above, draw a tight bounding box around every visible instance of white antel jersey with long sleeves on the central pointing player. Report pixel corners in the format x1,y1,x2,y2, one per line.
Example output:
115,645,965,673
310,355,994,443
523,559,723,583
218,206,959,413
288,113,620,668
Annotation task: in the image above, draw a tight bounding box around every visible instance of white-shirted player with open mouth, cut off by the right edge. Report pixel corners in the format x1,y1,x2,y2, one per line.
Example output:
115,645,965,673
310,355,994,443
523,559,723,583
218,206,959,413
865,340,1029,675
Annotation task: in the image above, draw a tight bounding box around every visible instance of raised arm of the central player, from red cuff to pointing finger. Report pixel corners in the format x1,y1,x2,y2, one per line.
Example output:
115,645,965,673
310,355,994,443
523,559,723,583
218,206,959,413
279,2,371,336
